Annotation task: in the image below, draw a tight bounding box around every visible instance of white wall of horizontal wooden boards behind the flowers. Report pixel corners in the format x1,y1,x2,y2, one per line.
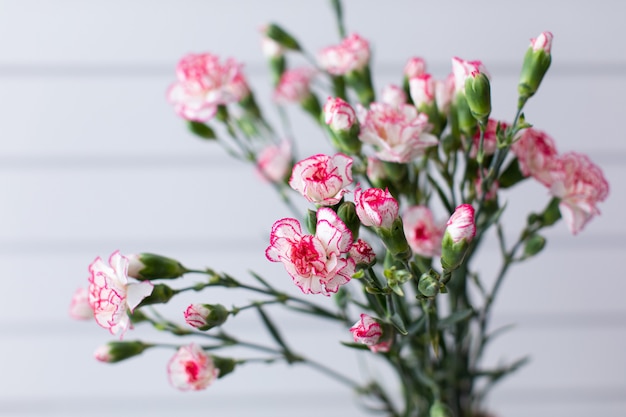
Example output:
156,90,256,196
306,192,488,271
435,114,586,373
0,0,626,417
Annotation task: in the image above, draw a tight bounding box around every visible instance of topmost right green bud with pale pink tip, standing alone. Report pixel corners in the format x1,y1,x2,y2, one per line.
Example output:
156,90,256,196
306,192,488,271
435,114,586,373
517,32,552,104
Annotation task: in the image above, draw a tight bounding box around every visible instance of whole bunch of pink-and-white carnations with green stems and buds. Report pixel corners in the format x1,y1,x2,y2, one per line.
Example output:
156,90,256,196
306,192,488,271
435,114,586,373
70,0,609,417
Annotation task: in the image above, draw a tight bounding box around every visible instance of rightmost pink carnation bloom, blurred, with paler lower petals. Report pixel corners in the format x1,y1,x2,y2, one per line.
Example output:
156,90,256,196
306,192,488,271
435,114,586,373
550,152,609,234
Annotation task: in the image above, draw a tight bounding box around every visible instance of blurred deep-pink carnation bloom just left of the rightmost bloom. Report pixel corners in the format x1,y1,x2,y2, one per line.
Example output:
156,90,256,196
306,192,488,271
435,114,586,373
511,128,558,187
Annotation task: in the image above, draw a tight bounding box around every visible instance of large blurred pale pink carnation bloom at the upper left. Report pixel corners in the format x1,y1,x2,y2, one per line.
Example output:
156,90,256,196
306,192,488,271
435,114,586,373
167,53,249,122
